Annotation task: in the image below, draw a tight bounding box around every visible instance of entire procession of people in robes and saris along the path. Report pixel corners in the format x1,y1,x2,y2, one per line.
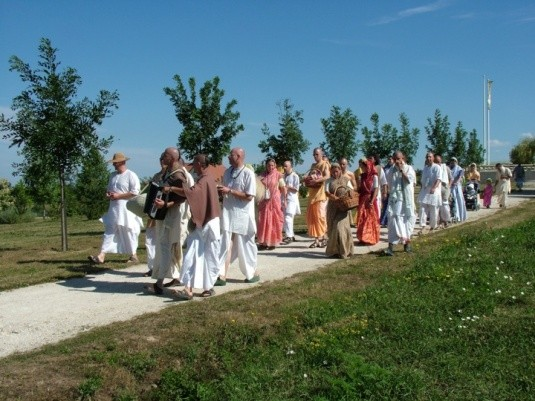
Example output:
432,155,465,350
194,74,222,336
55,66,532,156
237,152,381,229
89,147,512,300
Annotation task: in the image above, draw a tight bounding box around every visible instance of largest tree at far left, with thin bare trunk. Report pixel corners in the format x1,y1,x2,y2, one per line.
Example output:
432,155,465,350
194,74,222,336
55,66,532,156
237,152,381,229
0,38,119,251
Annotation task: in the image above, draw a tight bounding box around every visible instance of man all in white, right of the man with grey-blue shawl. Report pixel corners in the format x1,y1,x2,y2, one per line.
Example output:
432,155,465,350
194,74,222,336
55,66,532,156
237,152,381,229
418,152,442,230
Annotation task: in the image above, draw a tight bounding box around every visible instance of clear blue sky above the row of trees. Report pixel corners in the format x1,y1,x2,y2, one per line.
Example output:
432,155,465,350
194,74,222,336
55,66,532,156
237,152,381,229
0,0,535,182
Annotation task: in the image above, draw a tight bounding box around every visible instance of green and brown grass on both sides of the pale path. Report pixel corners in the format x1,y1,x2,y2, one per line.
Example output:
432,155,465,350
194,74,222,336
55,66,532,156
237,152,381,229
0,201,535,401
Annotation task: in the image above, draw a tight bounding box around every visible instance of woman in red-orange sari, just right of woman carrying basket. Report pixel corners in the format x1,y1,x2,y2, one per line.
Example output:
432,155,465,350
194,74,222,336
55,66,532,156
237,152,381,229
357,160,380,245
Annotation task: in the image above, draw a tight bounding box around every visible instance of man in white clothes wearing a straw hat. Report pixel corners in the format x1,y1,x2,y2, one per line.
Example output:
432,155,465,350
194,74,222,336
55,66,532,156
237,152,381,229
88,152,143,264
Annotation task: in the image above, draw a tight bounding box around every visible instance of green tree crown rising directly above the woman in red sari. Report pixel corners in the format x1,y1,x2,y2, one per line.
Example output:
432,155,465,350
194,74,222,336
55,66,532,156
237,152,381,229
361,113,399,159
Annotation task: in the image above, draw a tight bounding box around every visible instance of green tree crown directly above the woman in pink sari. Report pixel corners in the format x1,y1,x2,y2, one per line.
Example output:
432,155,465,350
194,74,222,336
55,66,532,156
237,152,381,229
258,99,310,166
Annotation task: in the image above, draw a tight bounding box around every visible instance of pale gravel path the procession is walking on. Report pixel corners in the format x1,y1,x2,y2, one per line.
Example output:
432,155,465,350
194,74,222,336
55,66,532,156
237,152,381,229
0,197,526,357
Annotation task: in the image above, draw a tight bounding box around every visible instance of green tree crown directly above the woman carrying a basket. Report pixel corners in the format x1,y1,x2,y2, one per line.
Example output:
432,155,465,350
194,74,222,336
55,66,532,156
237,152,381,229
320,106,360,165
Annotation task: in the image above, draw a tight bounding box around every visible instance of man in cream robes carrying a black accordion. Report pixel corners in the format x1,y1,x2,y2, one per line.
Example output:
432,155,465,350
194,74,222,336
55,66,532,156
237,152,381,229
152,147,194,295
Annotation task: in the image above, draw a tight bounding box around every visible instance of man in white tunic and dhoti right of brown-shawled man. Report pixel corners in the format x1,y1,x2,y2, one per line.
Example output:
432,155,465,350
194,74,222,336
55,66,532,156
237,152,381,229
215,148,260,286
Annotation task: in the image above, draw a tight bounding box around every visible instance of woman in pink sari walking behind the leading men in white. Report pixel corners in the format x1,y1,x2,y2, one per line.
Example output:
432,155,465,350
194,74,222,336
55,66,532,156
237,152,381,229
256,159,285,251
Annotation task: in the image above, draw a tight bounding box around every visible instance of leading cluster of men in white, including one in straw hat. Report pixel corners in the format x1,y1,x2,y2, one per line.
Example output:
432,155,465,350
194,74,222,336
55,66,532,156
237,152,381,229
89,147,262,300
